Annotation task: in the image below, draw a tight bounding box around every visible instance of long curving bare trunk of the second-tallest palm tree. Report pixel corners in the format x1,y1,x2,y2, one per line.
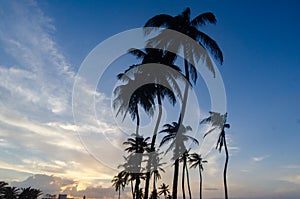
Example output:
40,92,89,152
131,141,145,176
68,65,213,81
144,89,162,199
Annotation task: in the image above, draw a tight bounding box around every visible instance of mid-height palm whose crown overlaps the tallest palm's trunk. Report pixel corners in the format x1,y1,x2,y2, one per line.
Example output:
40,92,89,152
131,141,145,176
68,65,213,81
160,122,199,198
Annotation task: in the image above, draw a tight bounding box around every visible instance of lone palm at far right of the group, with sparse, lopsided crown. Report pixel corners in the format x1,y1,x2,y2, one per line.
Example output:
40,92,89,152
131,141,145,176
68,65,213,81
200,111,230,199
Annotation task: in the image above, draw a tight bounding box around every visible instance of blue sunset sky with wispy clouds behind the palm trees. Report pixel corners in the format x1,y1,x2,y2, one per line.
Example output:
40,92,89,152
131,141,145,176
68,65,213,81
0,0,300,199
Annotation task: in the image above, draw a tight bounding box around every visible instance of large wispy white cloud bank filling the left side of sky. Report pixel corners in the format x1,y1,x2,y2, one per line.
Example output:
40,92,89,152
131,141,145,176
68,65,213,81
0,1,120,188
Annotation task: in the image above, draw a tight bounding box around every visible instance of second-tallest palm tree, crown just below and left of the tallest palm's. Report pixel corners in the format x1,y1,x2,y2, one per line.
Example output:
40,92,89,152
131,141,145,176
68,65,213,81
125,48,182,199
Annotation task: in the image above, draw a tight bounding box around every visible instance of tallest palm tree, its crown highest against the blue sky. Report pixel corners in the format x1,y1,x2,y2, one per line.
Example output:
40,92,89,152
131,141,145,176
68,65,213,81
144,8,223,127
